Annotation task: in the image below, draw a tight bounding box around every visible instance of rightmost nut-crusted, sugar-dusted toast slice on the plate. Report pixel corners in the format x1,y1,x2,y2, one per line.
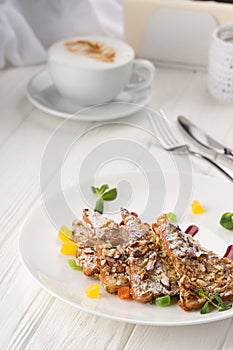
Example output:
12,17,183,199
155,214,233,311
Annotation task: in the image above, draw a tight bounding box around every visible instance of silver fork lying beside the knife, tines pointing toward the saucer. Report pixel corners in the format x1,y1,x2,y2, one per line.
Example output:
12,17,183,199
148,111,233,182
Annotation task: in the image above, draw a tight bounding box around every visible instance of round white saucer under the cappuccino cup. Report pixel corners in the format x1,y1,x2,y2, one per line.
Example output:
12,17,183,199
27,70,152,121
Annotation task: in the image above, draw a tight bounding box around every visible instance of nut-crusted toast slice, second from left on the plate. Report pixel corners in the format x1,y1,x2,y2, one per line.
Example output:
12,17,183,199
83,210,129,294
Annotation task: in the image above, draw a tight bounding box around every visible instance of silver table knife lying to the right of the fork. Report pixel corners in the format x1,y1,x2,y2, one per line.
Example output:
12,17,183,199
178,116,233,158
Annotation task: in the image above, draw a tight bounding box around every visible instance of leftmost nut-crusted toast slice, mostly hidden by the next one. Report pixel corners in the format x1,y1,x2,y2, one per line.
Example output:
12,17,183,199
72,219,100,278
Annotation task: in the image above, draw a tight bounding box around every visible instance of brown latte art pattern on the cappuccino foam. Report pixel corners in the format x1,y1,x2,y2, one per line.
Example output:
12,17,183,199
64,40,116,63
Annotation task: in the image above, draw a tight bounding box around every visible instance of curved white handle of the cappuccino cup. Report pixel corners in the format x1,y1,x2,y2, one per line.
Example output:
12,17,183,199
126,59,156,91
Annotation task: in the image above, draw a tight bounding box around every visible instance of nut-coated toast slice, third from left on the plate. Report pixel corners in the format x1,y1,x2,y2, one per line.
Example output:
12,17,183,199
121,209,179,303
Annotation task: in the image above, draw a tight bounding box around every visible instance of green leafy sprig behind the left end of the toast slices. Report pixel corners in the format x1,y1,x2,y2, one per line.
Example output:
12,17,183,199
91,184,117,214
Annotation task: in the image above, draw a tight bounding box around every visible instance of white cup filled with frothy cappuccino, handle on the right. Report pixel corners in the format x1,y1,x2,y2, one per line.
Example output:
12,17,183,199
48,36,155,106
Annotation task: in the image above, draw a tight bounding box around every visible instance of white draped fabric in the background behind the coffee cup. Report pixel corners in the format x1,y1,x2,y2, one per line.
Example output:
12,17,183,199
0,0,123,68
